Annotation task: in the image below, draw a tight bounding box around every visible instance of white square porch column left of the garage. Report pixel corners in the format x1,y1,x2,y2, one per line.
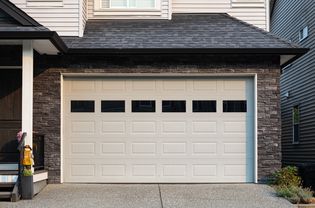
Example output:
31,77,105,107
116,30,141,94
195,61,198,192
22,40,33,148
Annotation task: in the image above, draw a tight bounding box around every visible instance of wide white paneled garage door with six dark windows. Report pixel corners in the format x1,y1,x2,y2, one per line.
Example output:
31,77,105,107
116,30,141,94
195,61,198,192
63,78,254,183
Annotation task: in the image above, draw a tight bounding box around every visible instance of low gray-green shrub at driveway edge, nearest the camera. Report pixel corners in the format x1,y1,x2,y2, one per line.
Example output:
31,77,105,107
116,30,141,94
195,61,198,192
276,186,313,204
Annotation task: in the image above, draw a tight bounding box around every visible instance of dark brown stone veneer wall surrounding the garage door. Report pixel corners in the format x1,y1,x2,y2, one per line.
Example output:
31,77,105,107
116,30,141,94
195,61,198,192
34,55,281,183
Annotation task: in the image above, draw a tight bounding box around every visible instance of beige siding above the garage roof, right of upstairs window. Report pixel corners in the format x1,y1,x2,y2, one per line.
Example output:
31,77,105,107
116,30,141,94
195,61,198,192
172,0,268,30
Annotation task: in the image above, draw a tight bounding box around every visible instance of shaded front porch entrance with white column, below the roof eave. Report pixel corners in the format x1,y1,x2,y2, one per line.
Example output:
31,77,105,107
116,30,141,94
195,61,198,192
0,38,64,201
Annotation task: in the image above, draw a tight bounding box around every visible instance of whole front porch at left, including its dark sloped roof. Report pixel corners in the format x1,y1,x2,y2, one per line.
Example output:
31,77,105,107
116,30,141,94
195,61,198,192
0,2,66,198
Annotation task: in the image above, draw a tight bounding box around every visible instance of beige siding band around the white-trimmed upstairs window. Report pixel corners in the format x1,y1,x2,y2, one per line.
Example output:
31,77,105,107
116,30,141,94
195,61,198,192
87,0,170,19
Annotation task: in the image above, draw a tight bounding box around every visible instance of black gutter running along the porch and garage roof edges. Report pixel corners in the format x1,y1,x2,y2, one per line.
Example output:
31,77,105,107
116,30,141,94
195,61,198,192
0,30,309,67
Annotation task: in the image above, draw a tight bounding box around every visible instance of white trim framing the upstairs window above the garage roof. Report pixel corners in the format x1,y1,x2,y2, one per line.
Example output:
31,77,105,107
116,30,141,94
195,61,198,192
94,0,161,12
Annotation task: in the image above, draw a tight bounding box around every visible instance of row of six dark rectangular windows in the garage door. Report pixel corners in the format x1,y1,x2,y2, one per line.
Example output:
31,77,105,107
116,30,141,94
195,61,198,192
71,100,247,113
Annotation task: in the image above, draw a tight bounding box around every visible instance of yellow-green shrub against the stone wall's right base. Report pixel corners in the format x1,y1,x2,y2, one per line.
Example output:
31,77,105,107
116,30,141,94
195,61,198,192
269,166,302,187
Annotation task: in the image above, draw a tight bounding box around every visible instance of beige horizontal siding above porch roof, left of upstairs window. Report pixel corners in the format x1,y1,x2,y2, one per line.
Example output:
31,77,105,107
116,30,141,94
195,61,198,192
10,0,80,36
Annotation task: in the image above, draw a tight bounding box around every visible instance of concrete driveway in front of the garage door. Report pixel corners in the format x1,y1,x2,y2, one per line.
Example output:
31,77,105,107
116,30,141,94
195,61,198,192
0,184,295,208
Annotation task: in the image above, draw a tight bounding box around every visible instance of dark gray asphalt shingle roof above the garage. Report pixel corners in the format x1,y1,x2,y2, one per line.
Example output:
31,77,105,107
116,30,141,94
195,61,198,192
62,14,299,49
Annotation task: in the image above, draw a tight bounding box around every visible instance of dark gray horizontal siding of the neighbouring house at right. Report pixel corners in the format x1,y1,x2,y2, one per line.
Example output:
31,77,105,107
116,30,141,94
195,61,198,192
271,0,315,165
